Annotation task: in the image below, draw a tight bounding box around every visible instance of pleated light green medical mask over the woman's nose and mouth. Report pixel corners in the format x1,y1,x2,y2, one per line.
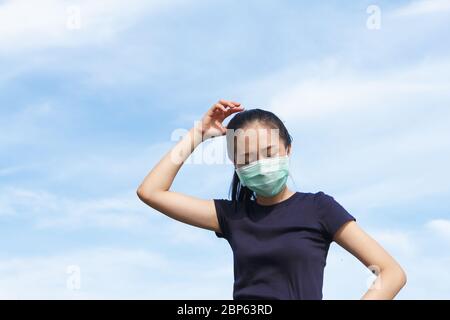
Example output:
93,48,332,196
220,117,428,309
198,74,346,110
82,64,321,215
236,155,289,197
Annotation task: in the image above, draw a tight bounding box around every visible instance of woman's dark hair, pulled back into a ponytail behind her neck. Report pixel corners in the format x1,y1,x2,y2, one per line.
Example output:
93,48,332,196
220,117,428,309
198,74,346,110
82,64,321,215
227,108,292,208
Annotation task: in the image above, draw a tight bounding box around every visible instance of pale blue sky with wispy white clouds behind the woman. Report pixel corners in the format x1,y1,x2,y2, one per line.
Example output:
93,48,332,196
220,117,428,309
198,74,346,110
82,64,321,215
0,0,450,299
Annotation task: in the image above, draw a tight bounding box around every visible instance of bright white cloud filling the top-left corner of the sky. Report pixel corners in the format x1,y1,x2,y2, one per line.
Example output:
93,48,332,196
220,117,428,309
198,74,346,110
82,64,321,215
0,0,186,54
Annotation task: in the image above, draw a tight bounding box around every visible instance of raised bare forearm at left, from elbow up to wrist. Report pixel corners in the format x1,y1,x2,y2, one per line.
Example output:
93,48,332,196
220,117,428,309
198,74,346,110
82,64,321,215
138,128,202,195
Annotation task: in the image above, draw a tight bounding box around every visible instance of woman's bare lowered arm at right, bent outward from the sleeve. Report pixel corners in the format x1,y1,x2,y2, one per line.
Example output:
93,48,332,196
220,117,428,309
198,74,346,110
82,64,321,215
333,221,406,300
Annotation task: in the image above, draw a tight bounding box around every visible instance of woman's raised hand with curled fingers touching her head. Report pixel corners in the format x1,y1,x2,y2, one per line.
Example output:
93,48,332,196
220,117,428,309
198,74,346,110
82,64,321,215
197,100,244,140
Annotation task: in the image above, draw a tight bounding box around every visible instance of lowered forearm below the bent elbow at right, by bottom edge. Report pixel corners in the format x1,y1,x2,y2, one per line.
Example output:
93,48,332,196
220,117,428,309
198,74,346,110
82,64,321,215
361,267,406,300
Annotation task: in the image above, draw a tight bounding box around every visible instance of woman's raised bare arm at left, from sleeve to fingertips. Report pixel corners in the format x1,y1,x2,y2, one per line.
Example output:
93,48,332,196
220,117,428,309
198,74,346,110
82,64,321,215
137,100,243,232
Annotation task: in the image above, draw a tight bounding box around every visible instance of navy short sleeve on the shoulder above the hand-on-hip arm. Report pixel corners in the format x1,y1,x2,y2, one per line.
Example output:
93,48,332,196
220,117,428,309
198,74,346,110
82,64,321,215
315,191,356,242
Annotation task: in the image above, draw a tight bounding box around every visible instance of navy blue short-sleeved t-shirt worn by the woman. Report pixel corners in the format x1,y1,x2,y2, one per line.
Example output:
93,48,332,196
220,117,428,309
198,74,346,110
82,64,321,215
214,191,356,300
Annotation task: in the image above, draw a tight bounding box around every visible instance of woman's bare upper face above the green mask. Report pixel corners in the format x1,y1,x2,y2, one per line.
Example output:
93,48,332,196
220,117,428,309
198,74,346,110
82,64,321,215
227,121,291,168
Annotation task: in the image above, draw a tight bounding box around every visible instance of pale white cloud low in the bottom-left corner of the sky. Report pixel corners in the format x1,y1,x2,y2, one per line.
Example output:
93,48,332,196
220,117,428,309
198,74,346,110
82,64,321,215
0,248,163,299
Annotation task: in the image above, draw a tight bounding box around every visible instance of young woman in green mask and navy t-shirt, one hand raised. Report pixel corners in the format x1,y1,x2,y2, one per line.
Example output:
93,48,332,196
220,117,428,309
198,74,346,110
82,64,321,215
137,100,406,300
